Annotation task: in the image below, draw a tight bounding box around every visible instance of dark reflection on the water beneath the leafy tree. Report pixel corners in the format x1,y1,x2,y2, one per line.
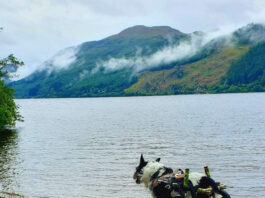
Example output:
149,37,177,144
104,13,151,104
0,130,18,192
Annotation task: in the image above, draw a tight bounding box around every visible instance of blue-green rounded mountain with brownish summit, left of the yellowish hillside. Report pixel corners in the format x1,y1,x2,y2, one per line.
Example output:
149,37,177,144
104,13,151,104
11,26,188,98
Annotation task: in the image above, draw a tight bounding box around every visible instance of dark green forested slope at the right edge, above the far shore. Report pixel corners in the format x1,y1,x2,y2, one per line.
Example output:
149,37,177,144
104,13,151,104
211,42,265,93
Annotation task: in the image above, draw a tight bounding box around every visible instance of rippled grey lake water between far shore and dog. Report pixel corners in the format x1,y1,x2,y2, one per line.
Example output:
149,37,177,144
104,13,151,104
0,93,265,198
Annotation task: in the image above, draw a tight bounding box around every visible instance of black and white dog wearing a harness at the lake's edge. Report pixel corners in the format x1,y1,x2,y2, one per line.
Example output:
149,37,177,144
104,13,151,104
133,155,230,198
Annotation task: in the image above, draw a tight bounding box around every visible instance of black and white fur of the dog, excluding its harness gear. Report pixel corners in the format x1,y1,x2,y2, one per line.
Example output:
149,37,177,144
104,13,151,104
133,155,225,198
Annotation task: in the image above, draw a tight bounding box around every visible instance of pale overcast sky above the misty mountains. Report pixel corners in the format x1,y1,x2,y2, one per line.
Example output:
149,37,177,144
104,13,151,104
0,0,265,77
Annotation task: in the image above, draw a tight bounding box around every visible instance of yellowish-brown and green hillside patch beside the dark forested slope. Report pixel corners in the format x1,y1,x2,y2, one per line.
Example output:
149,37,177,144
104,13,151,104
126,46,248,95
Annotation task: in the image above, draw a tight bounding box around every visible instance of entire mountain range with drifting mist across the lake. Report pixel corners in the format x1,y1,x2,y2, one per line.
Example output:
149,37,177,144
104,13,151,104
10,24,265,98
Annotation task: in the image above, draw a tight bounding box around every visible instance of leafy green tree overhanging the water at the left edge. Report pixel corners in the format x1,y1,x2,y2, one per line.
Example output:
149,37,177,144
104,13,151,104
0,54,24,131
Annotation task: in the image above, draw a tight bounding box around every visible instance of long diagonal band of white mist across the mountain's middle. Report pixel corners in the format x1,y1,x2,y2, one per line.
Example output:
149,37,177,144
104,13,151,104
92,27,235,73
